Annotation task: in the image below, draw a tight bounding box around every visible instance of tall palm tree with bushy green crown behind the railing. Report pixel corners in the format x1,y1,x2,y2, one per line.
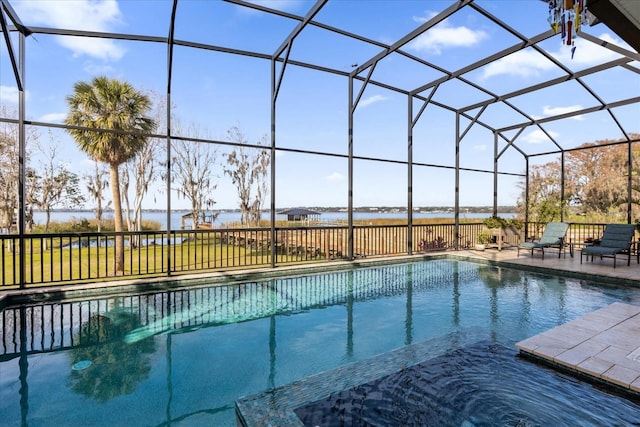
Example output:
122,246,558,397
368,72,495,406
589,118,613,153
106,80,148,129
65,77,156,273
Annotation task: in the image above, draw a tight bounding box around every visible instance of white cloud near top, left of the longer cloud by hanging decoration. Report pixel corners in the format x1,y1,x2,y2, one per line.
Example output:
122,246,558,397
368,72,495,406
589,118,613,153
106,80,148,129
407,13,488,55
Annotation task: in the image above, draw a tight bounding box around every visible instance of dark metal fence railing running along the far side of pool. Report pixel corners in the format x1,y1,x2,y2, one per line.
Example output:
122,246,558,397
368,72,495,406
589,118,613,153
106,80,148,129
0,223,632,289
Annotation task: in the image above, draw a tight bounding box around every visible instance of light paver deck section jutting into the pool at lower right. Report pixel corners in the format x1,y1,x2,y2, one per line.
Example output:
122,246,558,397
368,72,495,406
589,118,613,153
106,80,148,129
516,303,640,396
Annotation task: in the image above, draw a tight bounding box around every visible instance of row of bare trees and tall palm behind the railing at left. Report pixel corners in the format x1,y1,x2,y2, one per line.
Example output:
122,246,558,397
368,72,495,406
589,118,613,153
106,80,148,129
0,76,271,272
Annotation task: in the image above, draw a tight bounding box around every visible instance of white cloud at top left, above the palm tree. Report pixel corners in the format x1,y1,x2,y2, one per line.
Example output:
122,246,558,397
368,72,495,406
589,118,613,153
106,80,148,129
15,0,125,60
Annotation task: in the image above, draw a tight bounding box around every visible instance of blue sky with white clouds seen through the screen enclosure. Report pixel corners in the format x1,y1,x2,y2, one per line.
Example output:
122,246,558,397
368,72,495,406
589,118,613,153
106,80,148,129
0,0,640,209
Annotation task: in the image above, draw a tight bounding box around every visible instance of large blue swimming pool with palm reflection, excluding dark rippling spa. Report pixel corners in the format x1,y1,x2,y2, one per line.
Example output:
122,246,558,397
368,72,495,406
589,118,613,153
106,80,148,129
0,259,640,426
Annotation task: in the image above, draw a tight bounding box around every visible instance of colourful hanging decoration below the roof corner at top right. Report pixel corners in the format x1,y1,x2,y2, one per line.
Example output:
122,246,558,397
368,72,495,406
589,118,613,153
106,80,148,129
544,0,588,59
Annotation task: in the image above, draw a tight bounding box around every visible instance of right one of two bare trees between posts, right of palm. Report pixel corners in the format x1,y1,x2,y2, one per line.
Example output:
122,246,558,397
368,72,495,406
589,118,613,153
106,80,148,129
224,126,271,225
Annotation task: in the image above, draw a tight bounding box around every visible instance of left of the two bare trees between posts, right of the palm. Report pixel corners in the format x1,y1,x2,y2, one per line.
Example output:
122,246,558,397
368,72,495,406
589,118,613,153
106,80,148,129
171,126,218,228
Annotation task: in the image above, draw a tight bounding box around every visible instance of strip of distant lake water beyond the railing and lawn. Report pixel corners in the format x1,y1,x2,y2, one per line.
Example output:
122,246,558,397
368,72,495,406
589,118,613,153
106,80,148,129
34,211,516,230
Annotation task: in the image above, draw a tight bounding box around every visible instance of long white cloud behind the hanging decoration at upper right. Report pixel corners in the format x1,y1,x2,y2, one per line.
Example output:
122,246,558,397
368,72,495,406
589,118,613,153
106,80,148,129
482,33,631,79
